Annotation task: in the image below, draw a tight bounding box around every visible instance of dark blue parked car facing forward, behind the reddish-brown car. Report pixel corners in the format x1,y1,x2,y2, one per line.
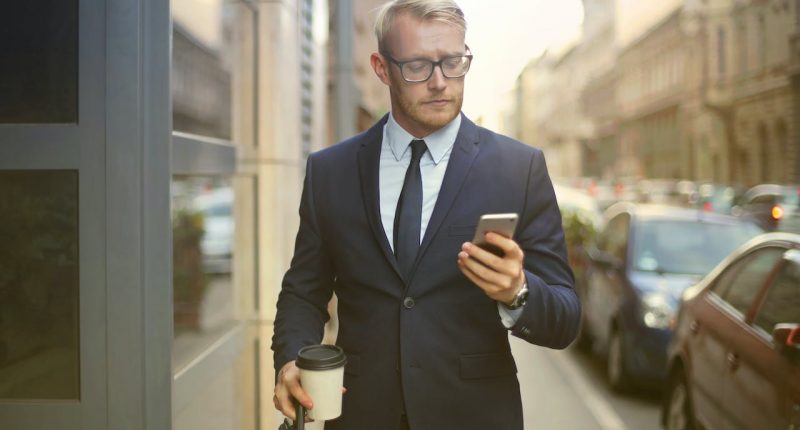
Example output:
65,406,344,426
578,203,761,390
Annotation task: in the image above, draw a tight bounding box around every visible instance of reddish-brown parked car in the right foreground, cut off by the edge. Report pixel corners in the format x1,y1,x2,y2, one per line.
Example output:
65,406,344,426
662,233,800,430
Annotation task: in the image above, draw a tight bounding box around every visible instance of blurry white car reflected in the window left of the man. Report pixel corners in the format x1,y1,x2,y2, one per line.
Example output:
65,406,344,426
194,187,234,274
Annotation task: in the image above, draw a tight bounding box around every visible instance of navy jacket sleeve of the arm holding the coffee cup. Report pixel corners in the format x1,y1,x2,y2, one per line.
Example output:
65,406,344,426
272,156,334,370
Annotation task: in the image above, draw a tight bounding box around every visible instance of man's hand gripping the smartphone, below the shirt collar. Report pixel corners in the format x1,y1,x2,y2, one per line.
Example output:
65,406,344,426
458,233,525,304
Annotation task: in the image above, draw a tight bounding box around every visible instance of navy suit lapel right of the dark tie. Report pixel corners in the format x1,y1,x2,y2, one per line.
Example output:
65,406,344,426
411,114,478,277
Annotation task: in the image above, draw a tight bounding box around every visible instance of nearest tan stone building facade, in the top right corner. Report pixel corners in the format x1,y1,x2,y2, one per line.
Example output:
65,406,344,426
693,0,800,186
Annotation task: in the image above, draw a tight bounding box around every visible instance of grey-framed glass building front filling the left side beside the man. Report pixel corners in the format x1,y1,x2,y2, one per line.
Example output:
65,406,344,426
0,0,328,430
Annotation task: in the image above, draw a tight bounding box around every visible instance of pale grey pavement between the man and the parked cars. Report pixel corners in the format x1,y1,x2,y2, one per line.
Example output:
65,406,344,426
511,337,661,430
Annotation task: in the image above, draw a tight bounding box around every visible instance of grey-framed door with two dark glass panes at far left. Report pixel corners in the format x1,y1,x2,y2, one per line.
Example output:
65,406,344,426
0,0,106,430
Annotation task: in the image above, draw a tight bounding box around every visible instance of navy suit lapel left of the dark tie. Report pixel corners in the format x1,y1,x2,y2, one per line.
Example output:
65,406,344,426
358,115,403,279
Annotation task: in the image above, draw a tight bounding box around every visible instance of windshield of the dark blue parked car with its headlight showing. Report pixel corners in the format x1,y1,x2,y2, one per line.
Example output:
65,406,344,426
633,220,761,275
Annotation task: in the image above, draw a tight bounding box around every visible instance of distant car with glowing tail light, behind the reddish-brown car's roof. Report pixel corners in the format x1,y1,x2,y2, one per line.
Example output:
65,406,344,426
733,184,800,233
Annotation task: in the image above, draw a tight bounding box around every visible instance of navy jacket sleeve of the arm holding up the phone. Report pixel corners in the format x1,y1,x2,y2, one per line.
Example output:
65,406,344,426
511,149,581,349
